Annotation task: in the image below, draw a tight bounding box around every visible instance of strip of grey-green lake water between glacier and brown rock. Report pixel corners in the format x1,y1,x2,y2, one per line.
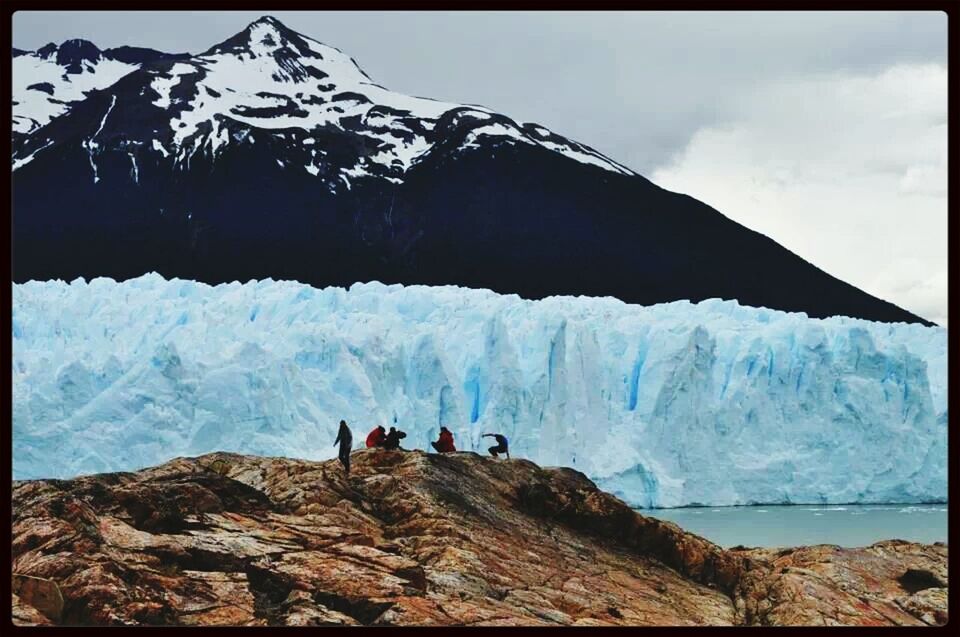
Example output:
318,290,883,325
637,504,947,548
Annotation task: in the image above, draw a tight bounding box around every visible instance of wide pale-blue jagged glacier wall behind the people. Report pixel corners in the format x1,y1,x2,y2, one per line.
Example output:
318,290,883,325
12,274,947,507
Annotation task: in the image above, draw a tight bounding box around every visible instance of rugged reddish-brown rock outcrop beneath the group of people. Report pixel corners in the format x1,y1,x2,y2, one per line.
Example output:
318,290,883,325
13,450,947,626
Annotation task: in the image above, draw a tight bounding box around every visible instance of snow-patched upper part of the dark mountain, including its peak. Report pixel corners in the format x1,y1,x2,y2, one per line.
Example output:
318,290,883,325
14,17,632,185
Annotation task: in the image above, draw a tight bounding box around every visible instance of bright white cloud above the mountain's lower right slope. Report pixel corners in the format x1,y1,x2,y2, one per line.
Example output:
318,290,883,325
651,64,947,324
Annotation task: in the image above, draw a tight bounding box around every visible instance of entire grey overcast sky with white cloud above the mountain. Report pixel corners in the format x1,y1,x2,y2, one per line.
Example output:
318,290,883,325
13,11,947,325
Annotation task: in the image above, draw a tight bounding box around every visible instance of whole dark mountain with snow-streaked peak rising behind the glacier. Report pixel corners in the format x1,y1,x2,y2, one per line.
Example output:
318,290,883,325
12,17,922,322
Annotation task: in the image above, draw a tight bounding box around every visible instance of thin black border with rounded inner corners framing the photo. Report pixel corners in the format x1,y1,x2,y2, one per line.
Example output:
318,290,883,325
0,0,960,635
